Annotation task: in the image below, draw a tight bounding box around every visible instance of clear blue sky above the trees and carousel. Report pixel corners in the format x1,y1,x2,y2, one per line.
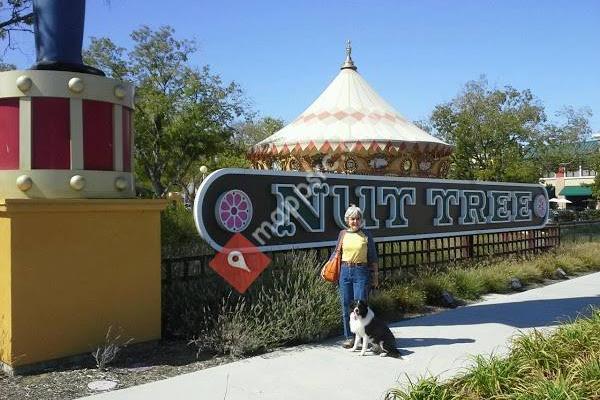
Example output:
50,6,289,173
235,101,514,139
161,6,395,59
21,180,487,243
7,0,600,131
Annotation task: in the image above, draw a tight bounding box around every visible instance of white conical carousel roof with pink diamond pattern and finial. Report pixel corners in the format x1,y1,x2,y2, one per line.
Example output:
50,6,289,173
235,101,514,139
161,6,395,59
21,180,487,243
250,43,452,155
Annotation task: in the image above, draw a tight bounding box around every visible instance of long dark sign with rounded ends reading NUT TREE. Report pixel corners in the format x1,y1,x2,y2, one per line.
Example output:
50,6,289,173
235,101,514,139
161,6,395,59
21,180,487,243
194,169,549,251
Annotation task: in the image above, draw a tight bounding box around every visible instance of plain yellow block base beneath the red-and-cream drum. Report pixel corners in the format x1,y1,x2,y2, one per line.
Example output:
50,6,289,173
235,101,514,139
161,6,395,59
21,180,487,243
0,199,165,369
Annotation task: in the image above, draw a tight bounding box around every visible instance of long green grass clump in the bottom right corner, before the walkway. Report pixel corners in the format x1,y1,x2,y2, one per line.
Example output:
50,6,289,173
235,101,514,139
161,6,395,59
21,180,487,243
386,309,600,400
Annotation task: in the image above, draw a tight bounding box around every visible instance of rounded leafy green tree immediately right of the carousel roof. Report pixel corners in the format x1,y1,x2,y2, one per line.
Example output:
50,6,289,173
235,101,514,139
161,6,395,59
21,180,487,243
430,78,546,182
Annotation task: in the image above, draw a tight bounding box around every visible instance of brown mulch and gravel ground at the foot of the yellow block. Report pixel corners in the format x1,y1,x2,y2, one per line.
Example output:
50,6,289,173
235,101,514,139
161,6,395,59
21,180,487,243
0,342,232,400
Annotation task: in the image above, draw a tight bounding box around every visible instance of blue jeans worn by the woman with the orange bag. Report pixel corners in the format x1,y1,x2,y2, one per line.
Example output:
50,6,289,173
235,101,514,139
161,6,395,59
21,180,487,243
339,263,371,338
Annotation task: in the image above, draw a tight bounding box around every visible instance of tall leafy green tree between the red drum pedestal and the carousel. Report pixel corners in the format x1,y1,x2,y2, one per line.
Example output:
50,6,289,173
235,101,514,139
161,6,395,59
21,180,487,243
84,26,251,197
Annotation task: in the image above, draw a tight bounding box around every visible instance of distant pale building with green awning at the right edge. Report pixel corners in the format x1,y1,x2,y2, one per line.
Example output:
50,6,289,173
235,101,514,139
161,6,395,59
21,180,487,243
540,138,600,209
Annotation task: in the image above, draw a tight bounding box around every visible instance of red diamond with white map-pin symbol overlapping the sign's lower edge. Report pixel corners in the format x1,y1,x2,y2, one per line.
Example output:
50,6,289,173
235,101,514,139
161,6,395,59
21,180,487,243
208,233,271,293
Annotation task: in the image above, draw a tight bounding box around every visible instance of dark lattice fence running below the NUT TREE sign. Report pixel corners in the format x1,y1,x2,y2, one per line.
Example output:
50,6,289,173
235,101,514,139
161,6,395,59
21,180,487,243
162,225,561,286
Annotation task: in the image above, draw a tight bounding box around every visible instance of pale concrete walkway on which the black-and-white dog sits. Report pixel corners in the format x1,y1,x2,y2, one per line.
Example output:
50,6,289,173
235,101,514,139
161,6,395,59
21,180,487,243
82,273,600,400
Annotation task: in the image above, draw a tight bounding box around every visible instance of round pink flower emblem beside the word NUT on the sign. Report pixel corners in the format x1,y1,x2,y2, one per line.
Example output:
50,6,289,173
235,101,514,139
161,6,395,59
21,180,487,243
215,189,252,233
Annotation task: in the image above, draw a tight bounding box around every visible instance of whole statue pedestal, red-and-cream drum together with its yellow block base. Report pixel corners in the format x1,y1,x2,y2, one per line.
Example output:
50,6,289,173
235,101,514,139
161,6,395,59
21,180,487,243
0,71,165,372
